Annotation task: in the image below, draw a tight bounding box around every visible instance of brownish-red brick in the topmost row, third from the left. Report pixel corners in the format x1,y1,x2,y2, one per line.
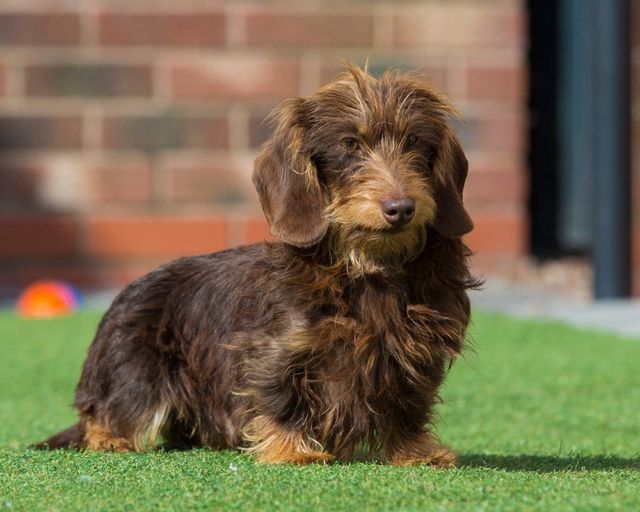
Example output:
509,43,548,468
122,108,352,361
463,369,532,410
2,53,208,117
245,9,373,48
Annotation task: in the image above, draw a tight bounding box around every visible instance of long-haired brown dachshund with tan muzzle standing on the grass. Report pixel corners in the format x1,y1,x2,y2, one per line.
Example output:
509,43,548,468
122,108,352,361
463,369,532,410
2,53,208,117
38,64,476,467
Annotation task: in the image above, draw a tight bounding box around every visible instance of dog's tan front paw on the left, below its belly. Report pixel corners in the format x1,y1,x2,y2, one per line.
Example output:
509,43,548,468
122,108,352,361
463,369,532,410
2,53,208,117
244,416,333,464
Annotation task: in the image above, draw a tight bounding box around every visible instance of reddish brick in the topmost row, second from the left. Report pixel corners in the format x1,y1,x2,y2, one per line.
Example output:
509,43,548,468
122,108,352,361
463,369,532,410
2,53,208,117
99,13,225,47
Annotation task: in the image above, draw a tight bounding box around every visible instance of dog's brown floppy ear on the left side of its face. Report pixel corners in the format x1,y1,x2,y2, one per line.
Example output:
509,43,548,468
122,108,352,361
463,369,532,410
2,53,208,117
253,98,328,247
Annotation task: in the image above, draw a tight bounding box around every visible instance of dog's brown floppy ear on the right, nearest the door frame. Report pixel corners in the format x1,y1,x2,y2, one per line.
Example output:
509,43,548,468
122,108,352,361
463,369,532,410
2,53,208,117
433,127,473,238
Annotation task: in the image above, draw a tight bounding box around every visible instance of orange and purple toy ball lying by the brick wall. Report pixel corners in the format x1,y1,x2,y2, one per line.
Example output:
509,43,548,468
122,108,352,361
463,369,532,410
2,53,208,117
16,281,80,318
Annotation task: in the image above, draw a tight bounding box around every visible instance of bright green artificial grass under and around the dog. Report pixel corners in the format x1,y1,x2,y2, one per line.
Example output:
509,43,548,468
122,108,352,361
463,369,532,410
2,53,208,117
0,312,640,511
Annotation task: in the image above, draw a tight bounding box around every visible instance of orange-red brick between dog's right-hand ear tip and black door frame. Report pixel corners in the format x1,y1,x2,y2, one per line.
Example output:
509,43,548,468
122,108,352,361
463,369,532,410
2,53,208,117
465,212,527,256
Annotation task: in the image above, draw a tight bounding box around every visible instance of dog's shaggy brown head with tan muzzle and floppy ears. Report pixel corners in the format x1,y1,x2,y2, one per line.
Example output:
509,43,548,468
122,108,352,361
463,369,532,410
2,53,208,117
253,65,473,272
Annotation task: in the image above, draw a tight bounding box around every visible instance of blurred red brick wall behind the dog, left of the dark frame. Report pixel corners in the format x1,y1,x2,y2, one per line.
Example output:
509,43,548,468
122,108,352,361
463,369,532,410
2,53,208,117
0,0,526,292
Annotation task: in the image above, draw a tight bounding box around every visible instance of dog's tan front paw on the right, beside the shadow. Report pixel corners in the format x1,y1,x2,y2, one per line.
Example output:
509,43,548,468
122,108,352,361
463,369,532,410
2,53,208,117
385,429,457,468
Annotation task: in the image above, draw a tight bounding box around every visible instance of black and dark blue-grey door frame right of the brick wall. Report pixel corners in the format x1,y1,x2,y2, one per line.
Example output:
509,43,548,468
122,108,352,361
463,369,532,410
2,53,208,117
527,0,631,299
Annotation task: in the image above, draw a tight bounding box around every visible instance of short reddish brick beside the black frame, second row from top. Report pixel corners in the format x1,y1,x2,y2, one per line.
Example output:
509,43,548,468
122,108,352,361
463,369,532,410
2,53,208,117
466,65,525,102
